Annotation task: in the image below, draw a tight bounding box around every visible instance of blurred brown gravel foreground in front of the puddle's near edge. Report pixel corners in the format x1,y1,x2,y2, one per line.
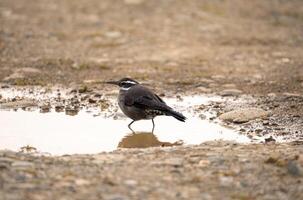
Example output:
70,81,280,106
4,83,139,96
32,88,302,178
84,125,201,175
0,141,303,200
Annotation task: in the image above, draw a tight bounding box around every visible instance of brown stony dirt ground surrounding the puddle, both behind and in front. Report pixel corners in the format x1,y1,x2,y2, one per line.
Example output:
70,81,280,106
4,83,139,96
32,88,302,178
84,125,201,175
0,0,303,200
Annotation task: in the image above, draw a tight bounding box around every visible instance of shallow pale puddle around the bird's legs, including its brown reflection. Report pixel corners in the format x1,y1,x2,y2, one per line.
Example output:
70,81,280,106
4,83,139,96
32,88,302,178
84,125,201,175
0,89,251,155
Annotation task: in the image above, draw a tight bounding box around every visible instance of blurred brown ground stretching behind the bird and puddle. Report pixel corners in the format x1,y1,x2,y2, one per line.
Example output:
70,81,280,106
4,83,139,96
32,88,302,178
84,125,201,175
0,0,303,93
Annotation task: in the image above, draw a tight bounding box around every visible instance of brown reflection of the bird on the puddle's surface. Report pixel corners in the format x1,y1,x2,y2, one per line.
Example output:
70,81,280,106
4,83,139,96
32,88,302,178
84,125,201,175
118,132,183,148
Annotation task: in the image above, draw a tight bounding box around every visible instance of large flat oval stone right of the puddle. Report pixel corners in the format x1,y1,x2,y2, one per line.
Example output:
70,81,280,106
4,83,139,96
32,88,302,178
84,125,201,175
219,108,269,123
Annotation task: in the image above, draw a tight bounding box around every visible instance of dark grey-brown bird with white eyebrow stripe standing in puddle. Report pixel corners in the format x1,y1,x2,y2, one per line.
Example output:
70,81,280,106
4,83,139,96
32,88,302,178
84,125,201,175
105,78,186,133
